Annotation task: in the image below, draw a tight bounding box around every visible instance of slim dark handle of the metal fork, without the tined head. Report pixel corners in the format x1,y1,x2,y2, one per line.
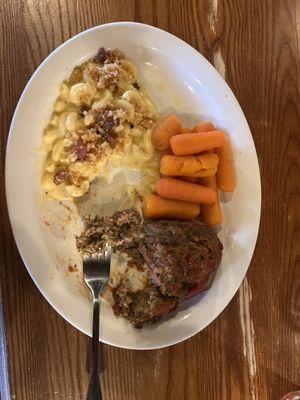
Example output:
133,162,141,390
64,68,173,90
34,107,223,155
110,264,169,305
86,293,102,400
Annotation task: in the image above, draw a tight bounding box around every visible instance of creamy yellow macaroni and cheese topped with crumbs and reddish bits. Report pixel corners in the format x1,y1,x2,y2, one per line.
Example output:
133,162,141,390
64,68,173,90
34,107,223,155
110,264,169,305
42,48,159,200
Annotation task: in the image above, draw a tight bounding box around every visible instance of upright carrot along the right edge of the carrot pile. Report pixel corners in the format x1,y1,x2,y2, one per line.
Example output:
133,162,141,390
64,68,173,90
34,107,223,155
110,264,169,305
215,140,235,192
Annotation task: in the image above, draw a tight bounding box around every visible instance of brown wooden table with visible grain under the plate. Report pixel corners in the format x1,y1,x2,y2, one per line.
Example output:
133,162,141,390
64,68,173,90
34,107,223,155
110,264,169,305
0,0,300,400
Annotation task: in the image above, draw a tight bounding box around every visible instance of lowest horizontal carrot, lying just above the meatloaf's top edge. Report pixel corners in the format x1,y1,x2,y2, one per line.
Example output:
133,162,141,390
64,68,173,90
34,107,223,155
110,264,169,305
143,194,200,219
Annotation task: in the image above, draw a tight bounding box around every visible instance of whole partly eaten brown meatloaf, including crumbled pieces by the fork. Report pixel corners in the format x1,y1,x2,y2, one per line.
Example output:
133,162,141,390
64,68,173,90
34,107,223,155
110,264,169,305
77,209,222,328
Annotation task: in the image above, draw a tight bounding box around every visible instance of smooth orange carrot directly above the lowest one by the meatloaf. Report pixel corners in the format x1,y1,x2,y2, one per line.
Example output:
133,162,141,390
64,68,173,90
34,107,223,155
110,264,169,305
156,178,217,204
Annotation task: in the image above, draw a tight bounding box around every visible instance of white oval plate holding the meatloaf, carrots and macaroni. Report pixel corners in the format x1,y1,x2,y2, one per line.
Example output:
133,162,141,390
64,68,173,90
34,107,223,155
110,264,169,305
6,22,261,349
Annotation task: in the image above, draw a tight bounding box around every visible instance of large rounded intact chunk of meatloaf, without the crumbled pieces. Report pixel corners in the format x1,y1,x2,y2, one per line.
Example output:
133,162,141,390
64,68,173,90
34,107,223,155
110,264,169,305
140,220,222,299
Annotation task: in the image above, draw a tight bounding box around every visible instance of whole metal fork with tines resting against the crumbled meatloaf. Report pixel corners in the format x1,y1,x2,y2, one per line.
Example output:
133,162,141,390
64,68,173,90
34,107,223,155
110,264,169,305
83,245,111,400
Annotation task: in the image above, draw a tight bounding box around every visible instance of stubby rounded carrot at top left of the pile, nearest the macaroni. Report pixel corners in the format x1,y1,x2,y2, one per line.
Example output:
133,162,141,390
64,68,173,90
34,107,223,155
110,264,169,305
152,114,182,150
